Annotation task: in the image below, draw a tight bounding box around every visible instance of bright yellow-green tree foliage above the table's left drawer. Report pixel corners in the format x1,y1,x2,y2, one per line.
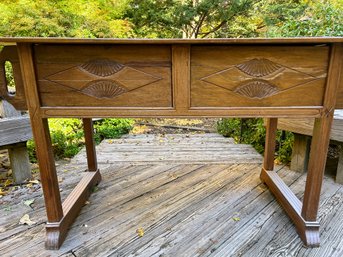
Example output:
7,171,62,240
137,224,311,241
0,0,132,38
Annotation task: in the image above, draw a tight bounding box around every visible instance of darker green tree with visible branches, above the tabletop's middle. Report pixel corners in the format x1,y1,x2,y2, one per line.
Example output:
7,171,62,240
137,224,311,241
126,0,258,38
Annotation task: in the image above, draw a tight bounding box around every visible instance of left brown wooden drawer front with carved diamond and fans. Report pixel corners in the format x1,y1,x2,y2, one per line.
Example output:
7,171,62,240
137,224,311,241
34,45,172,107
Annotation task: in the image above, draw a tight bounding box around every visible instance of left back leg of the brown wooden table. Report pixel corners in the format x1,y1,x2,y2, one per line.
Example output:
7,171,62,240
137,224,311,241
82,118,98,171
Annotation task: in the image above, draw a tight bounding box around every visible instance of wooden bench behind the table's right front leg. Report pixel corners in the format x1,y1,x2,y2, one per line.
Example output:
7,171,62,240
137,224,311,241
278,110,343,184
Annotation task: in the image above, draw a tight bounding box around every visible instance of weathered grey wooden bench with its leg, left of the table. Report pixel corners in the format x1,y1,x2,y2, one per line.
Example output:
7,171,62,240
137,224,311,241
0,101,32,184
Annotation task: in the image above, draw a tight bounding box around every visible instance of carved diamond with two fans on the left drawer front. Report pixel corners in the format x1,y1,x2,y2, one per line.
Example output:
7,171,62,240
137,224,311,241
45,59,162,98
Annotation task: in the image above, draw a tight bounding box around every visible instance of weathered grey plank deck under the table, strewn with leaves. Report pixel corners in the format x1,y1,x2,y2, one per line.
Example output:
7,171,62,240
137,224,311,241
0,134,343,257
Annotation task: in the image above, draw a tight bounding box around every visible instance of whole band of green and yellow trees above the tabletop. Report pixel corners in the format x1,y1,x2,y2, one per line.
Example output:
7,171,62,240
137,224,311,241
0,0,343,38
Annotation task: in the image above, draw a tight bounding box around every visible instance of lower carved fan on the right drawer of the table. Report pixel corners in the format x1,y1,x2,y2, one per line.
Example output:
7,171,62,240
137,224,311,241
234,80,279,99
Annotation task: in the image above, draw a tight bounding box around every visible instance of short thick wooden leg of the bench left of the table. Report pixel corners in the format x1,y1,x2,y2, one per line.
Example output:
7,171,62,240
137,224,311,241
8,143,32,184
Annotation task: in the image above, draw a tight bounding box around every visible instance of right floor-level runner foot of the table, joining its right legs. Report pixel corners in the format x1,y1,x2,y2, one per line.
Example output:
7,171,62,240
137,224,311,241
260,168,320,247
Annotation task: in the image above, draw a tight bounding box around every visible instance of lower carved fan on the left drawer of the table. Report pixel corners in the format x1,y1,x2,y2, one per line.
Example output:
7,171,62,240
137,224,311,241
81,80,127,98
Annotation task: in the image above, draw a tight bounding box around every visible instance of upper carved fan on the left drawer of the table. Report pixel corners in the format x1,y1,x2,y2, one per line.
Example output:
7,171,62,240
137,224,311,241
79,59,125,77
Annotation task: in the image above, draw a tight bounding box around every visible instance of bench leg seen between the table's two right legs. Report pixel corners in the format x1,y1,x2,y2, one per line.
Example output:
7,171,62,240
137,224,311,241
290,133,311,172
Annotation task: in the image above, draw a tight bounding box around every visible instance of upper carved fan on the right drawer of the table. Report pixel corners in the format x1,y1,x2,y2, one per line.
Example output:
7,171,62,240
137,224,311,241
236,58,282,77
